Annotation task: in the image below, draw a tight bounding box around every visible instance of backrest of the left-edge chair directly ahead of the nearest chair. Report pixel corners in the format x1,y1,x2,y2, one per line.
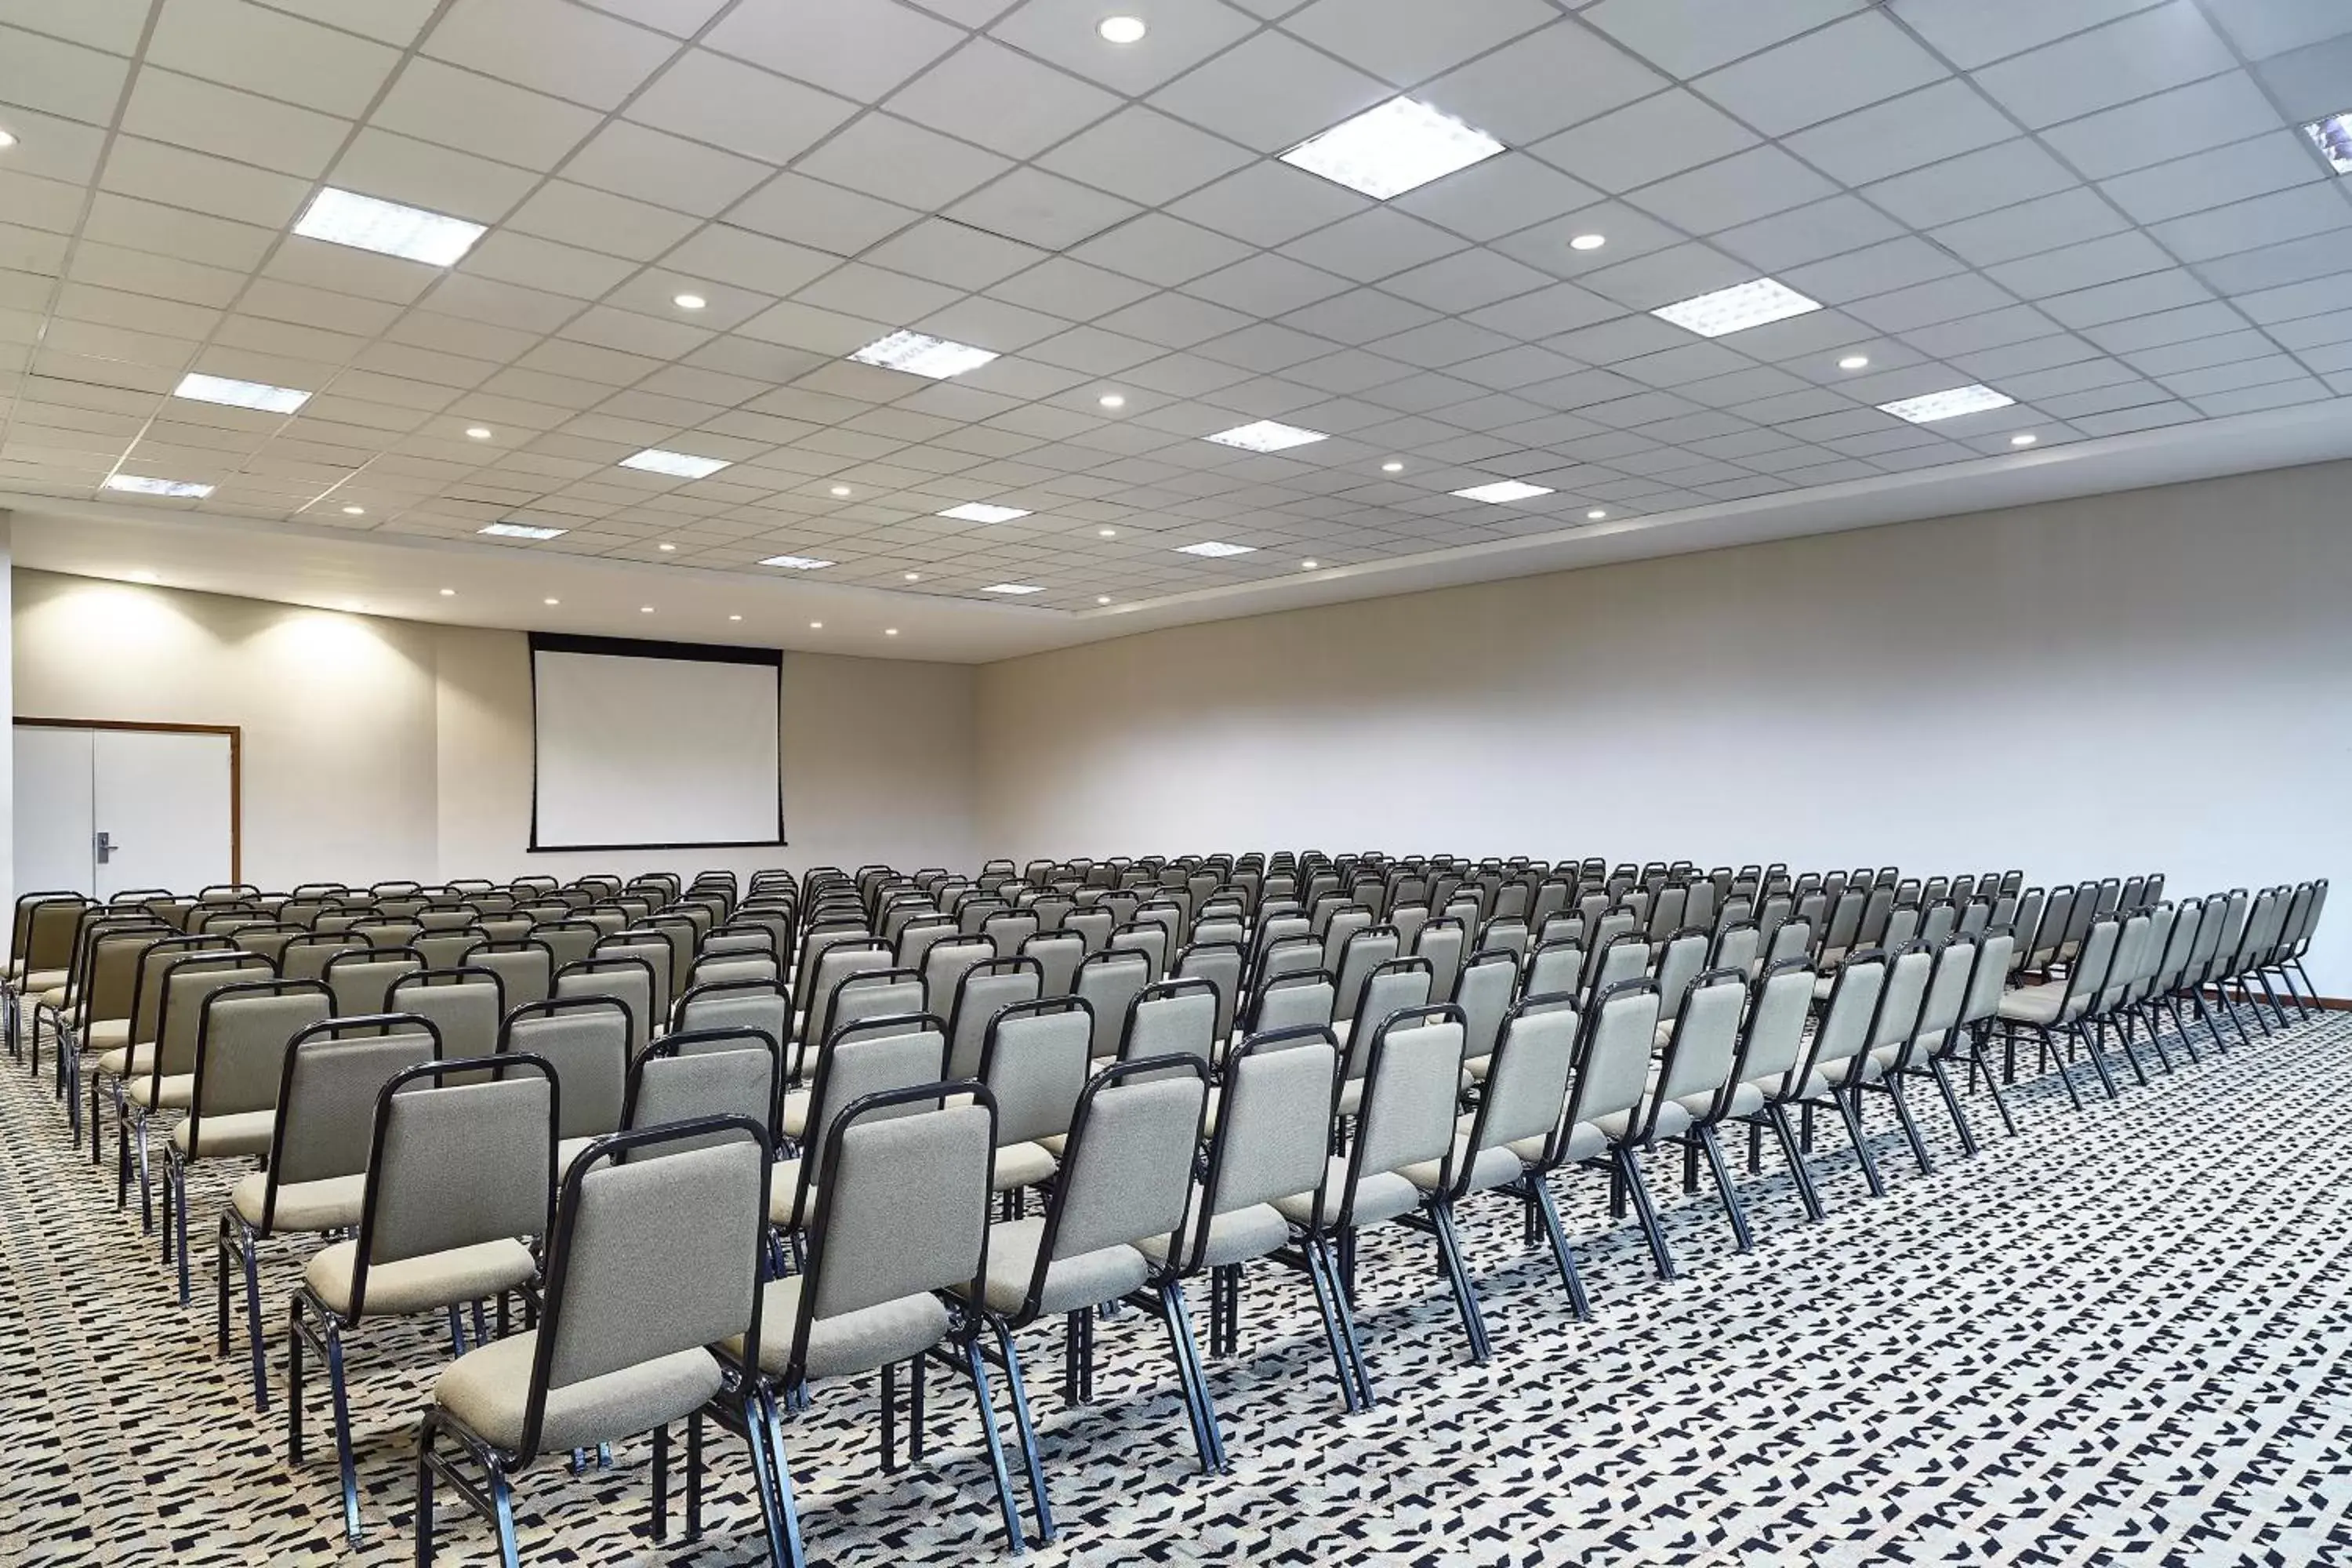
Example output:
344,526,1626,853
343,1055,557,1321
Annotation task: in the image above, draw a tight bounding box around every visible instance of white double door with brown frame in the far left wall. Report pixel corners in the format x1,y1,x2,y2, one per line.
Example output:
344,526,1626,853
14,724,235,898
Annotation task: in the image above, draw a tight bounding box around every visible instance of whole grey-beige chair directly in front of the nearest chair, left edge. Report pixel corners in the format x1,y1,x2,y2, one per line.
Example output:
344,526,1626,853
287,1053,555,1547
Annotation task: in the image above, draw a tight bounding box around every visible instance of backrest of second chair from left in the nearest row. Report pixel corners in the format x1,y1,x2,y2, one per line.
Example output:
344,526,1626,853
795,1079,1000,1385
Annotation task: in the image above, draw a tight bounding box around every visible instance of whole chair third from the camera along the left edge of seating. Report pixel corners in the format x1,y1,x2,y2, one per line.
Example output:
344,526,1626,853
214,1013,440,1410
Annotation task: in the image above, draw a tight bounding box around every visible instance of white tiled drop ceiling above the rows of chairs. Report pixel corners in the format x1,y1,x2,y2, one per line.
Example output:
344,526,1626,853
0,0,2352,659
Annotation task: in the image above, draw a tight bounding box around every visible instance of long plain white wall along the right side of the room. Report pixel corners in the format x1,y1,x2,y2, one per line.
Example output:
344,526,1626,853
978,466,2352,994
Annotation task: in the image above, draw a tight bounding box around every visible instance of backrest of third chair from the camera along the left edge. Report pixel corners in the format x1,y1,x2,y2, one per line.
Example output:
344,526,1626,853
261,1013,440,1203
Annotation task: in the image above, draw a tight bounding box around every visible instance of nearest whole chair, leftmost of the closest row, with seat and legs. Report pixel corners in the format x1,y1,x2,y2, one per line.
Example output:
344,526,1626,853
414,1119,781,1568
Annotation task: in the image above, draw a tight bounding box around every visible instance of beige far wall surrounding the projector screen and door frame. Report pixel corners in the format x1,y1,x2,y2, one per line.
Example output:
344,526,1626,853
14,572,978,886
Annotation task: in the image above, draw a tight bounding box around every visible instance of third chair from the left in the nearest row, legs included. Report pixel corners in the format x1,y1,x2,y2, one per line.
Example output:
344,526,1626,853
967,1055,1218,1544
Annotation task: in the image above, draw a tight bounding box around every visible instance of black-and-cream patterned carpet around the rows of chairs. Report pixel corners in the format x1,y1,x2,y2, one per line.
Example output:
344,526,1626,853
0,1013,2352,1568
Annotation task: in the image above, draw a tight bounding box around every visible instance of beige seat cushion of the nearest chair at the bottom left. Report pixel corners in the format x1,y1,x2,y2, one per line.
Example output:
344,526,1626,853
433,1328,720,1453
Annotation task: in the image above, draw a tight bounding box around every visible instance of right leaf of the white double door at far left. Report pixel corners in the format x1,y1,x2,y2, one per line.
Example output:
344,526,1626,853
89,729,230,898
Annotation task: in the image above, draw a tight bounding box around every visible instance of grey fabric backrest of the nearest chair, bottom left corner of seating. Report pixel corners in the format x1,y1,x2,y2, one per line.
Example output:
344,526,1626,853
517,1121,769,1462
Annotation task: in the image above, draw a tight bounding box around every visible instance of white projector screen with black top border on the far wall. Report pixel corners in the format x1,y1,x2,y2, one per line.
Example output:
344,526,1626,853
532,633,783,848
